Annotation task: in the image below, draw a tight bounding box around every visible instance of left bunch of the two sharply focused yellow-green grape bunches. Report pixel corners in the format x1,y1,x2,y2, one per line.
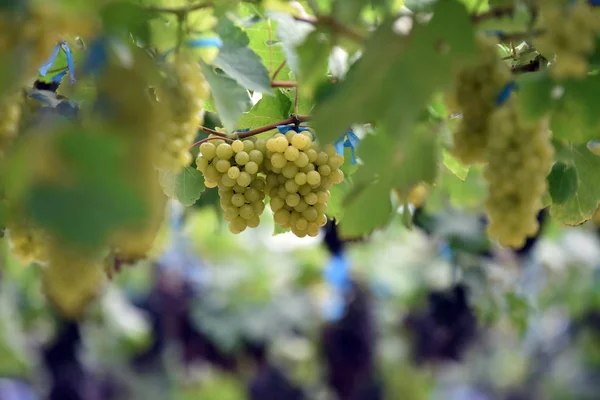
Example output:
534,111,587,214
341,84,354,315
196,138,265,234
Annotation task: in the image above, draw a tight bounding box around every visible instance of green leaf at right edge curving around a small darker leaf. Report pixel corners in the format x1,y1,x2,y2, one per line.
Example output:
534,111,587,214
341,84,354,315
550,145,600,225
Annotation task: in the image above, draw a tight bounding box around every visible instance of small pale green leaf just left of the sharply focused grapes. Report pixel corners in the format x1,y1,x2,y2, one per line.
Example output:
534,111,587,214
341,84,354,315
159,167,206,206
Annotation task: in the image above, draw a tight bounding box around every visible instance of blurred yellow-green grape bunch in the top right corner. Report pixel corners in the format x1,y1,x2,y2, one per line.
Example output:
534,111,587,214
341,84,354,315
533,0,600,79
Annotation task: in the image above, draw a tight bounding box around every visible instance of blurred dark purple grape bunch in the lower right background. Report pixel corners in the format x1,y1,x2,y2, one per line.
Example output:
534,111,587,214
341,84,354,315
403,284,477,364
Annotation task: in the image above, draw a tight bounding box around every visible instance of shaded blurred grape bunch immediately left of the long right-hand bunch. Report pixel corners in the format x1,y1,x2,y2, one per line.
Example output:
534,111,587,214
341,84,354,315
453,37,512,164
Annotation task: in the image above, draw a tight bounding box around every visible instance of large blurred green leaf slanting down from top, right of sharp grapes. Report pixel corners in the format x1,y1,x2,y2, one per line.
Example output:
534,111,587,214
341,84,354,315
313,0,476,143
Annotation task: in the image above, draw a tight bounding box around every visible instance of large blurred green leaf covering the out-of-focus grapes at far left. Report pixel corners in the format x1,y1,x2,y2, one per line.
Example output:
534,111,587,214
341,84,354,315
24,131,147,249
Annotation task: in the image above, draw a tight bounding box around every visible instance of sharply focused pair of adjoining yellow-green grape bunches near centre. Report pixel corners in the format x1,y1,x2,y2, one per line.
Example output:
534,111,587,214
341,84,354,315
196,130,344,237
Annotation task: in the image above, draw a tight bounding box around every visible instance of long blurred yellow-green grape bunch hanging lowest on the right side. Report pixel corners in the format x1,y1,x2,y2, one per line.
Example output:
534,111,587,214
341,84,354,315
484,100,554,248
